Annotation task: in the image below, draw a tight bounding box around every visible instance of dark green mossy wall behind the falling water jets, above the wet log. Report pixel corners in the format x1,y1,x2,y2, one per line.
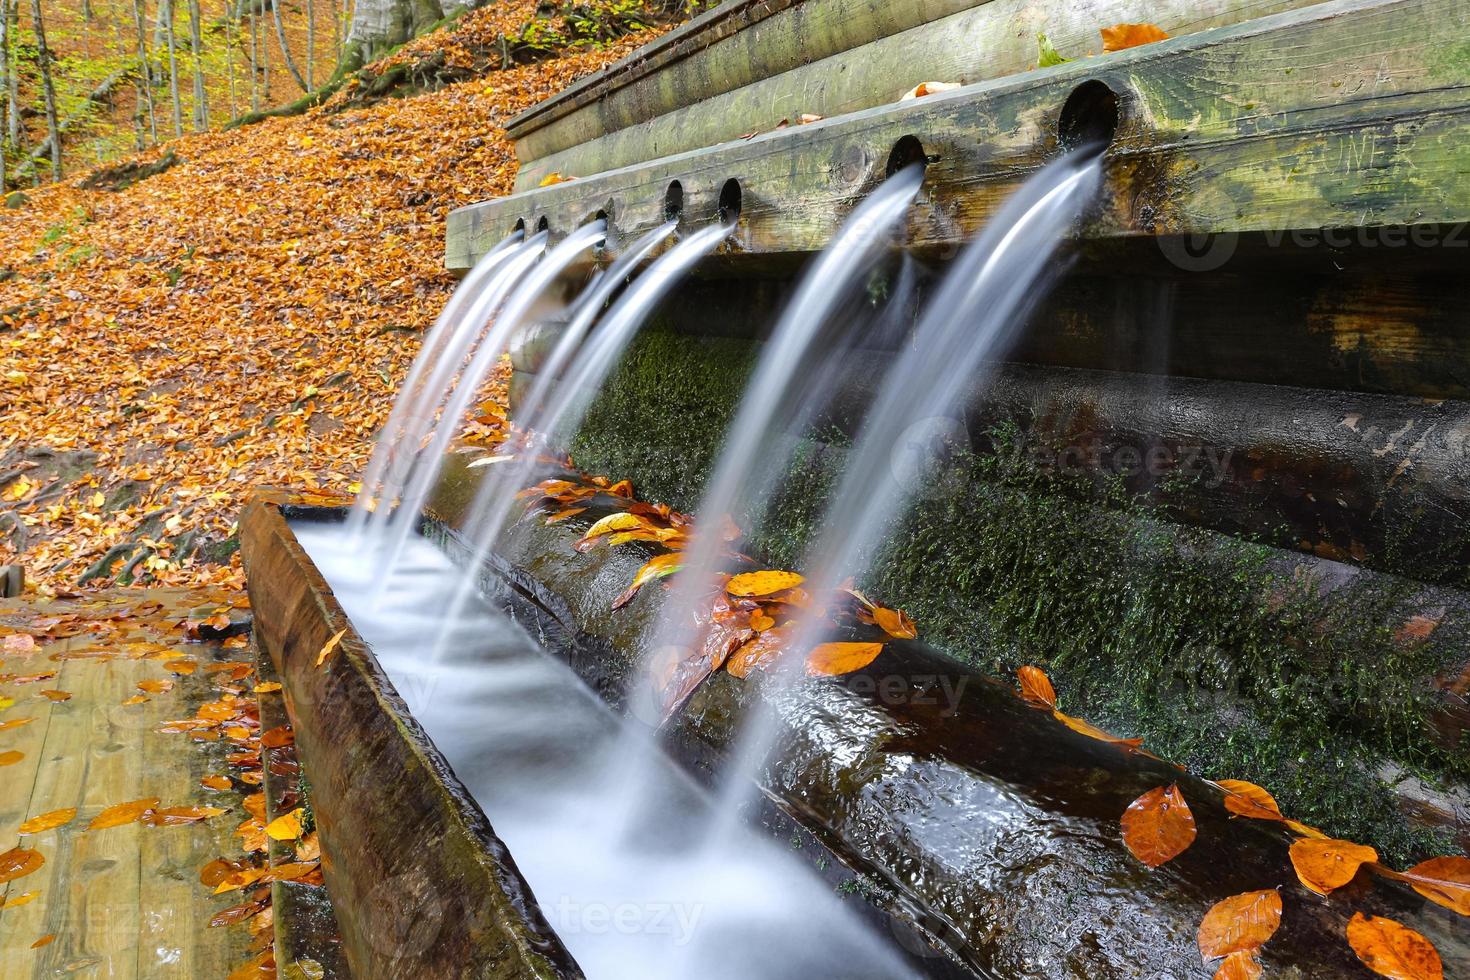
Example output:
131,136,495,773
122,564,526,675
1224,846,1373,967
570,329,1470,861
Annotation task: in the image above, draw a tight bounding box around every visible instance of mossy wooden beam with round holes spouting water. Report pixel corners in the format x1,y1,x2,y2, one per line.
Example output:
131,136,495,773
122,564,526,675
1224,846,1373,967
445,0,1470,267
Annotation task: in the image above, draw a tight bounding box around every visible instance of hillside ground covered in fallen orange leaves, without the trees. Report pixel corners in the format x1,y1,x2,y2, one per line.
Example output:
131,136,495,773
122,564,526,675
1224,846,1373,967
0,0,667,594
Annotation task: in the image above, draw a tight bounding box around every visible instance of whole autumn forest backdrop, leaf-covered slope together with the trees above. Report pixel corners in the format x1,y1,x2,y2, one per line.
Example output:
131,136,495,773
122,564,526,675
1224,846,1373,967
0,0,698,592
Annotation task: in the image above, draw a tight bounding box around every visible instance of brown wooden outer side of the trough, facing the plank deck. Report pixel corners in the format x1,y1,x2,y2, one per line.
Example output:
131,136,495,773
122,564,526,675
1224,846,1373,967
240,497,582,980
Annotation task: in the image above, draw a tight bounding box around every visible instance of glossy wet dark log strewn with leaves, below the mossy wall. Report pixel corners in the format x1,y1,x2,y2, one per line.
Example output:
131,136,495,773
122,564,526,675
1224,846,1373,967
417,470,1470,980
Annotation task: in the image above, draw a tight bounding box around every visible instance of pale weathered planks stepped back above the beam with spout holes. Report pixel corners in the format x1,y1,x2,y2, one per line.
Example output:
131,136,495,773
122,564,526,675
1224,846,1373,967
516,0,1322,190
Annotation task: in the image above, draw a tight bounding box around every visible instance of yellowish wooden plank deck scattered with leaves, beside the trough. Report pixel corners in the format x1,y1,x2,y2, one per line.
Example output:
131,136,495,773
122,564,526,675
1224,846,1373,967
0,589,250,980
